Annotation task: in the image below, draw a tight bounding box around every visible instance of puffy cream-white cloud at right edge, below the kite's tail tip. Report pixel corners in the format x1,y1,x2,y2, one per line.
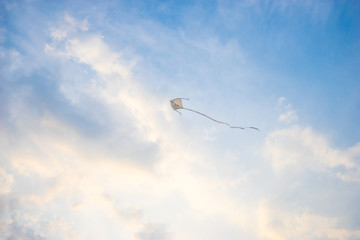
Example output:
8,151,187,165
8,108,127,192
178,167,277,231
264,126,360,182
